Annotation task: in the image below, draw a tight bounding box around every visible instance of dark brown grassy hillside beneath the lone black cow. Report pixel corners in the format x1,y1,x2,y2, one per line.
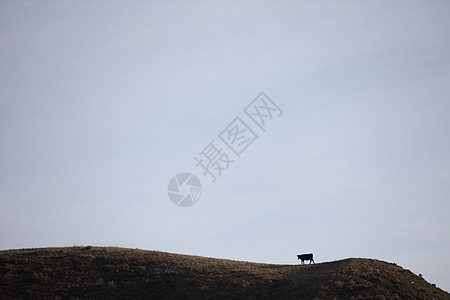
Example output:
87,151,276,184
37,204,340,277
0,247,450,299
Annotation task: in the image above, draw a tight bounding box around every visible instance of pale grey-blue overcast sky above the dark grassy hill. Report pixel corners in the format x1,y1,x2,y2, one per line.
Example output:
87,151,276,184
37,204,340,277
0,0,450,291
